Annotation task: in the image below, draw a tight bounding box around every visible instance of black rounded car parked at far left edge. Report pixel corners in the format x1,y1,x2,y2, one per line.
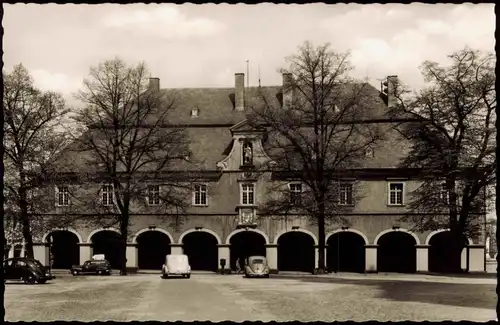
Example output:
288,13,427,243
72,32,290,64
3,257,56,284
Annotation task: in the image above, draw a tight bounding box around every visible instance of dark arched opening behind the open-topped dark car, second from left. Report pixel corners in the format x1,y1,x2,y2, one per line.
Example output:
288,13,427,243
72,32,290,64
91,230,122,269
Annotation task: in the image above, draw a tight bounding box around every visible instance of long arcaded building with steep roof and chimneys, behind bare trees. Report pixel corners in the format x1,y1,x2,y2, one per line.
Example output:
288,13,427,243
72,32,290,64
21,74,485,273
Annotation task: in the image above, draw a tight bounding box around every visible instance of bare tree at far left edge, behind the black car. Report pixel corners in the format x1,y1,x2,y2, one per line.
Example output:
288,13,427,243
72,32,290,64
3,64,68,258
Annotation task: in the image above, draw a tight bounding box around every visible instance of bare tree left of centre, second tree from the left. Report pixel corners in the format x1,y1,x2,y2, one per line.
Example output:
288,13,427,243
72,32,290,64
73,58,190,275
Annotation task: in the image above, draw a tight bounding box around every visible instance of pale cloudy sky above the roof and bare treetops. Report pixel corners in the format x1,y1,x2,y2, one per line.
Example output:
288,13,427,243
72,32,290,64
3,3,495,105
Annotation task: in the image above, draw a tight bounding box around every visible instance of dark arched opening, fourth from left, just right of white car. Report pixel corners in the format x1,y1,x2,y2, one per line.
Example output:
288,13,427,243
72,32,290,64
182,231,218,272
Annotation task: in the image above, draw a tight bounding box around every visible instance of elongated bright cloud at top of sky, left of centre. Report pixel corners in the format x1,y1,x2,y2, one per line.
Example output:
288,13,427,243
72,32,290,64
102,5,225,39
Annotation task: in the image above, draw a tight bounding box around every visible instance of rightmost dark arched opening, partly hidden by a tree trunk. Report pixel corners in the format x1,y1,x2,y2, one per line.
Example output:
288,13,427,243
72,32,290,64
429,231,468,273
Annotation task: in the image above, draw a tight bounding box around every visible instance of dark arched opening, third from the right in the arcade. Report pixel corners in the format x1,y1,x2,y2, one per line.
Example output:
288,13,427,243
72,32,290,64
326,231,365,273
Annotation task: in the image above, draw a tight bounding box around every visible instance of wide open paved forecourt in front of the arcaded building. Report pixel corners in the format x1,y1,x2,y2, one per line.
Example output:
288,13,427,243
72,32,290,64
4,274,496,322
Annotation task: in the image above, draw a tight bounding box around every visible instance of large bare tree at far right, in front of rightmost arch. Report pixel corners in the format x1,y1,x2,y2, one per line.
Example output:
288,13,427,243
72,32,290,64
391,48,497,272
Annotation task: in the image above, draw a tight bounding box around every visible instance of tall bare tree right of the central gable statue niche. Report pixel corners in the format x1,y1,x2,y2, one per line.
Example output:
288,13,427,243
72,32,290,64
248,42,382,273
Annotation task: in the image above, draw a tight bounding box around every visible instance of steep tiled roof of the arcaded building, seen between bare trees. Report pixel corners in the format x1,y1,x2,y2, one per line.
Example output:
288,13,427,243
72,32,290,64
50,83,408,171
